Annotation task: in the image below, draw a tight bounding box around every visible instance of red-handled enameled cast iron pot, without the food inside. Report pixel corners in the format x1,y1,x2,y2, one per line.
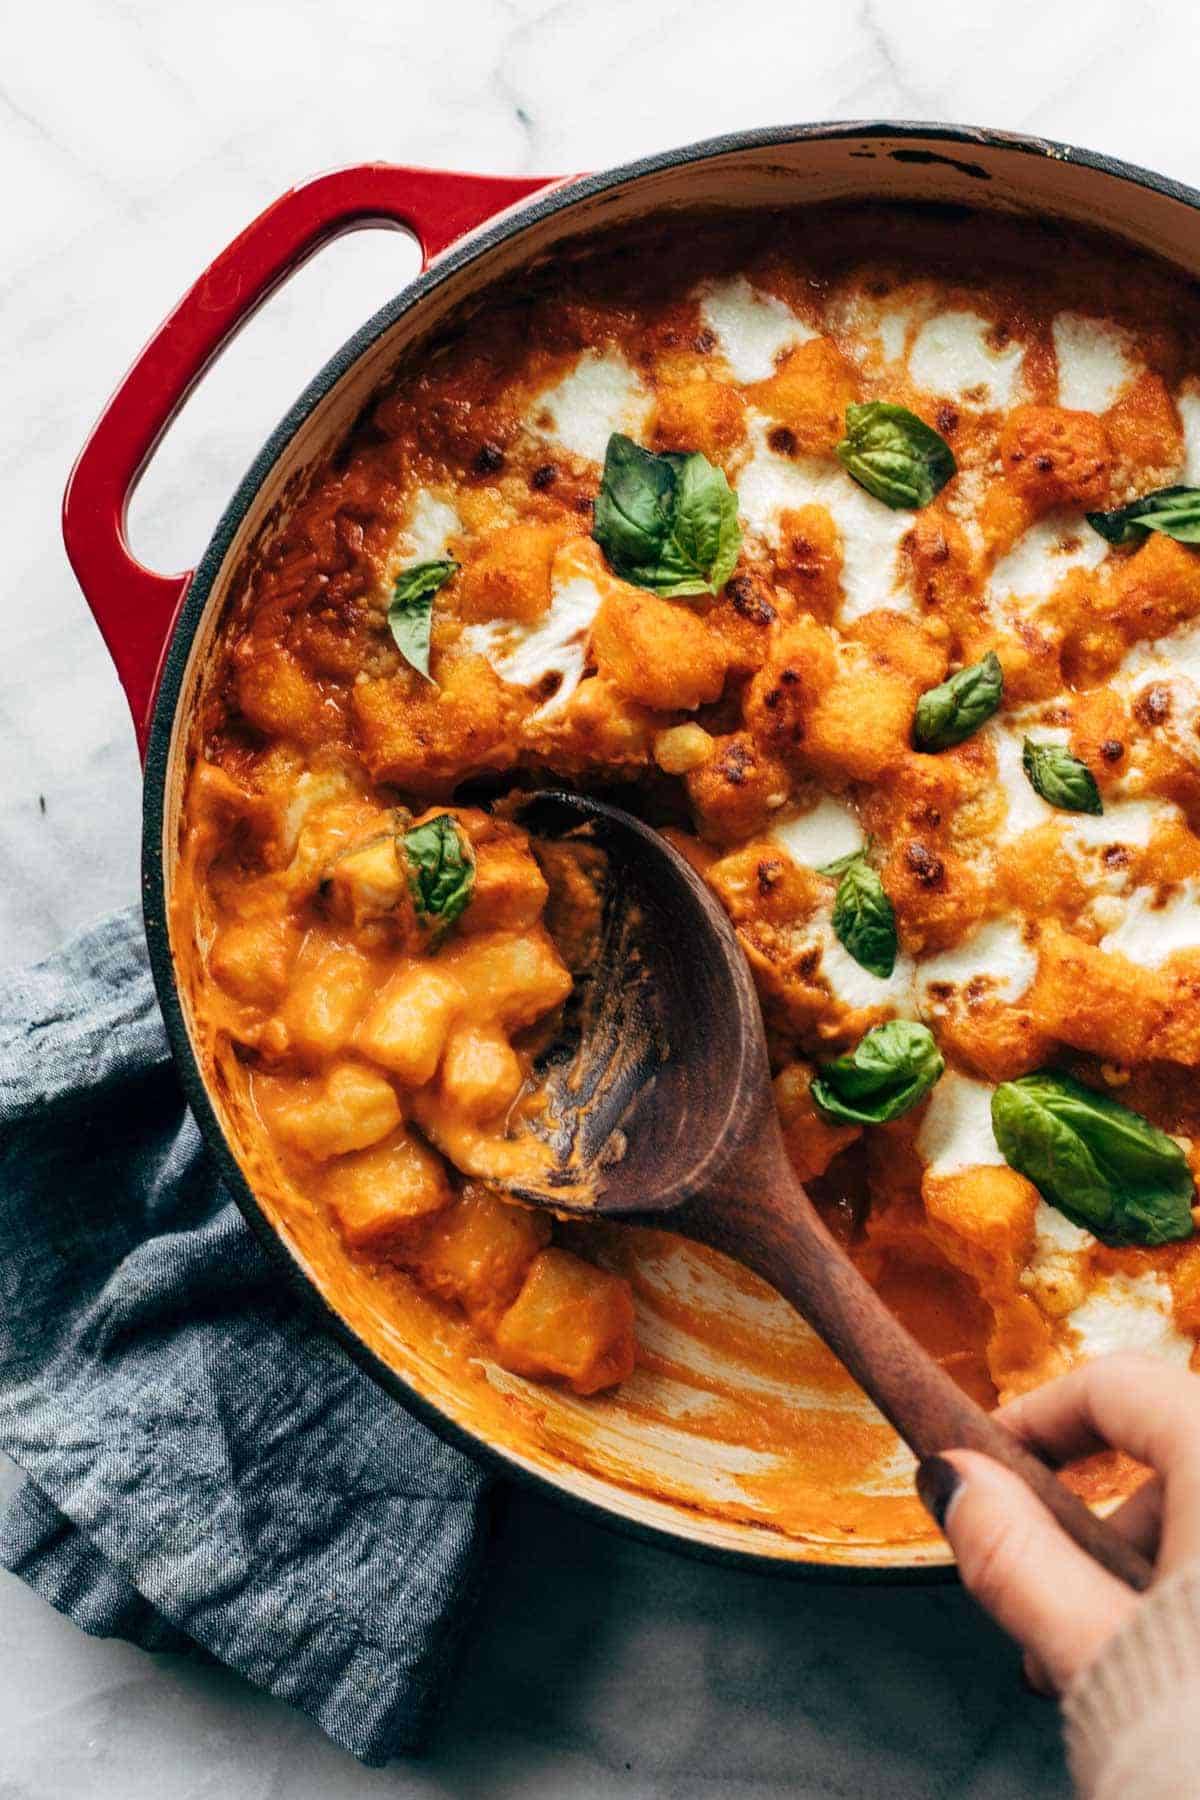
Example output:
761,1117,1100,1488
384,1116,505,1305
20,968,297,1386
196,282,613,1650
63,122,1200,1580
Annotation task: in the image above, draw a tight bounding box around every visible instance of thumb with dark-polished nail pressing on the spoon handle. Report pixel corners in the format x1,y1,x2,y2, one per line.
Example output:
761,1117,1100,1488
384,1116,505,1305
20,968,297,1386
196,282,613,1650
918,1451,1137,1694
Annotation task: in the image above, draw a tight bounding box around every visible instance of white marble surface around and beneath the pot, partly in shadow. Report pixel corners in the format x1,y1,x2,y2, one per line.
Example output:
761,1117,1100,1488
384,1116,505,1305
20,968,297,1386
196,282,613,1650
0,0,1200,1800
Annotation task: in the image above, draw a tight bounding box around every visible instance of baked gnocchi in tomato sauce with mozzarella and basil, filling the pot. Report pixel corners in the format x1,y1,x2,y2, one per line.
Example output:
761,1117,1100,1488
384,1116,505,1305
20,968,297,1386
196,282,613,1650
173,209,1200,1400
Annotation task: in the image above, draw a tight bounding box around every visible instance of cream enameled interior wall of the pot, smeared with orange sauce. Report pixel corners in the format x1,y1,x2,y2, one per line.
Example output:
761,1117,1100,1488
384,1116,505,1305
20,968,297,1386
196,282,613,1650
146,126,1200,1575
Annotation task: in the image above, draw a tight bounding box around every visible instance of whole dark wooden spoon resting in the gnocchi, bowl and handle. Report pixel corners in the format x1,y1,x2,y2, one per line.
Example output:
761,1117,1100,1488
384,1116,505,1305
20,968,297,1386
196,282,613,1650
509,792,1151,1589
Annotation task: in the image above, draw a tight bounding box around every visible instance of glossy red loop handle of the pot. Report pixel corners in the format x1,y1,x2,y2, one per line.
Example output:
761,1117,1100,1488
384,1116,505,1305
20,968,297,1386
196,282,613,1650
63,162,564,756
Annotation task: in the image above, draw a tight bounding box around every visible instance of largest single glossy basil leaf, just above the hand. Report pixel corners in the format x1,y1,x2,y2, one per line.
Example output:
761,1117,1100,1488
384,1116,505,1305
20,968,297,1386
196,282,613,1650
991,1069,1195,1244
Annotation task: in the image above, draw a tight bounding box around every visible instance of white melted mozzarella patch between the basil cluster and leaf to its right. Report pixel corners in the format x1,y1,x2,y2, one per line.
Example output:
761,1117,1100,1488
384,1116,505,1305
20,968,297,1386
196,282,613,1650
738,419,918,625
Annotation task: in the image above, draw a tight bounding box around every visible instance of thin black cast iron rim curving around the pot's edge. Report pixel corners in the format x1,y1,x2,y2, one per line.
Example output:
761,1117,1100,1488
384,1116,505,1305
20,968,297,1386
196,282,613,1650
142,119,1200,1586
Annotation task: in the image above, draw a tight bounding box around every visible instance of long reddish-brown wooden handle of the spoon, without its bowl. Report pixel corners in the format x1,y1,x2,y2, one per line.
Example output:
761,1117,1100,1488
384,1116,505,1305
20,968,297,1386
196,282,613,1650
690,1145,1153,1591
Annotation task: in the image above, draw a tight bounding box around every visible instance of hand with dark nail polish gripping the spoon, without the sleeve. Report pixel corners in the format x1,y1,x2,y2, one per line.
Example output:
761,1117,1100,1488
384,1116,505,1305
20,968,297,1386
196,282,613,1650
918,1355,1200,1694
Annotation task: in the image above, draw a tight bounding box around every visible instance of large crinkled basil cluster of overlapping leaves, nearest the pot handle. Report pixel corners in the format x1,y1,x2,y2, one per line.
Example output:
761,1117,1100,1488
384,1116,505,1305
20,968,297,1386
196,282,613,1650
592,432,741,599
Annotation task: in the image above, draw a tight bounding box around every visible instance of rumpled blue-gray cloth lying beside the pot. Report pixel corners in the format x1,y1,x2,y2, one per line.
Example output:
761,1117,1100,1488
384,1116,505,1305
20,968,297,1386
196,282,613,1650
0,913,488,1762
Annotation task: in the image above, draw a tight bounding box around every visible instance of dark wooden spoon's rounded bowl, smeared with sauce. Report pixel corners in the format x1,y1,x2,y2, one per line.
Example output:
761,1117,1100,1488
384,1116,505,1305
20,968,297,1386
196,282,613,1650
513,792,770,1215
